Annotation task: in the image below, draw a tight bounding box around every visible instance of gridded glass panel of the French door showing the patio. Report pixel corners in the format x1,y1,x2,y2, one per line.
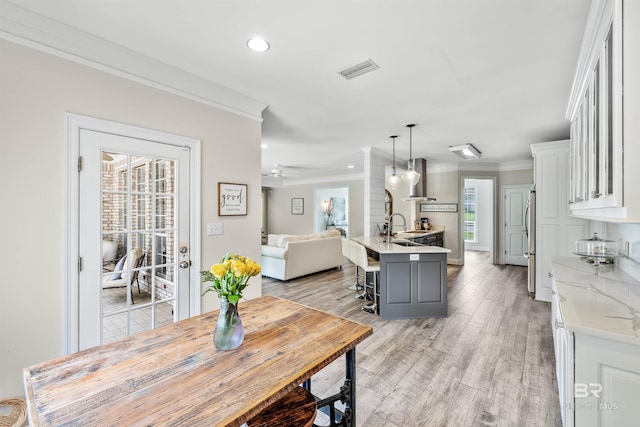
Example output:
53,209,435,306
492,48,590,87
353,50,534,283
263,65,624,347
101,152,176,343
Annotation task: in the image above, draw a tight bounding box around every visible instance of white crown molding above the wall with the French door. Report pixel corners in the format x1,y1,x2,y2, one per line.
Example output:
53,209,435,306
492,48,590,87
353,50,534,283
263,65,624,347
0,0,268,121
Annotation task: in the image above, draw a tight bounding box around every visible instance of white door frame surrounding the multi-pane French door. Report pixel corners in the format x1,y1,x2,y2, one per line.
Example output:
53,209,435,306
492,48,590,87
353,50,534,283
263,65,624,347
62,113,201,354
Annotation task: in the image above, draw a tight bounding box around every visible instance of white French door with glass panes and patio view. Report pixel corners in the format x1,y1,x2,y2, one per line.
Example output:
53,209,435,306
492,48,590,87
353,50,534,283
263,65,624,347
78,129,190,350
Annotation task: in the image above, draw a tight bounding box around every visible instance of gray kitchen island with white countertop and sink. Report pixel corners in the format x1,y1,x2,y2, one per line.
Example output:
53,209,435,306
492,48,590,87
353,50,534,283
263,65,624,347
352,236,451,319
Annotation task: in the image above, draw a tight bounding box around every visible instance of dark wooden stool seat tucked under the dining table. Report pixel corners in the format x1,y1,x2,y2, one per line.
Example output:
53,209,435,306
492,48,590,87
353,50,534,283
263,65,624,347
247,387,316,427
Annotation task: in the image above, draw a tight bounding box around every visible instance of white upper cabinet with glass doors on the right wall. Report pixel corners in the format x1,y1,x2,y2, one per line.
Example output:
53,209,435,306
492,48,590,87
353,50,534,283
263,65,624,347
567,0,640,222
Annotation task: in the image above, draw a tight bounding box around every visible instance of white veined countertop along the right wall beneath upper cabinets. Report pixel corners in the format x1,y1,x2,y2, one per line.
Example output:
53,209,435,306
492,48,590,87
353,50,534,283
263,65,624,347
551,257,640,345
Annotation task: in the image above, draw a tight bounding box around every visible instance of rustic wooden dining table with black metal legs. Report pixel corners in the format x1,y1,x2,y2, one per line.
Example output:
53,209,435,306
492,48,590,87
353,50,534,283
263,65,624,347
24,296,373,426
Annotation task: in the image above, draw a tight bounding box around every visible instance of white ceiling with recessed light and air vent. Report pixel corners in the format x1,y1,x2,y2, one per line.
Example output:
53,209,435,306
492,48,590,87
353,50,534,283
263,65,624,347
5,0,591,183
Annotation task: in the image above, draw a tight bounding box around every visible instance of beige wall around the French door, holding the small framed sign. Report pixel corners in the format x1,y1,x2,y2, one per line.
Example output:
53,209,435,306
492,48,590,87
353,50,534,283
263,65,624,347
0,39,261,398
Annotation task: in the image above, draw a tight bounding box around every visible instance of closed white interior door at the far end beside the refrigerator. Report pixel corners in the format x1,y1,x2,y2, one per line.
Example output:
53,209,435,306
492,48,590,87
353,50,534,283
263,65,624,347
504,185,531,266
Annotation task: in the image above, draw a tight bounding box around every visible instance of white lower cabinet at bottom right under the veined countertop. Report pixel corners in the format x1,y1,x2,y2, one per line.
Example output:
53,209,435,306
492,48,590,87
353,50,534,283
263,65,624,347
551,283,640,427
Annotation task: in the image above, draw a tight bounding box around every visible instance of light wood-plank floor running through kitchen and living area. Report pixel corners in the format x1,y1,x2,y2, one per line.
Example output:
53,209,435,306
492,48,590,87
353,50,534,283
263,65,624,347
262,251,561,427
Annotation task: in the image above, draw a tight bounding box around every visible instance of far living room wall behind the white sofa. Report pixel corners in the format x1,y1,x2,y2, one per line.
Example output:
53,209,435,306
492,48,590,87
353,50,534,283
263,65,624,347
267,180,364,236
